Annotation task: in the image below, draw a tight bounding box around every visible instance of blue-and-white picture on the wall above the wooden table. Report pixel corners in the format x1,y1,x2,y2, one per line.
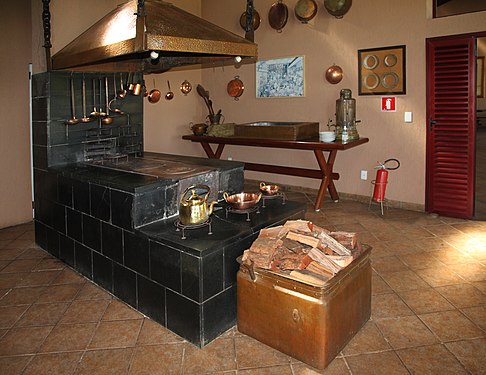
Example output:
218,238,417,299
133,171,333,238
256,56,305,98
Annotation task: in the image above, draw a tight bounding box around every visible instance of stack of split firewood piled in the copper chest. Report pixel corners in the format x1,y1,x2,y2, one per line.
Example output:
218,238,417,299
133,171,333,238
242,220,361,286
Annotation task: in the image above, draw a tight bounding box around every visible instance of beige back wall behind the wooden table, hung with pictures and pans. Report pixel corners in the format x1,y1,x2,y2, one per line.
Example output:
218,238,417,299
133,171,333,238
184,0,486,209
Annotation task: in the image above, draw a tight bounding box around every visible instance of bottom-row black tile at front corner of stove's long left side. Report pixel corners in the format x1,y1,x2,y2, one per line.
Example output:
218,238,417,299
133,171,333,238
165,289,201,347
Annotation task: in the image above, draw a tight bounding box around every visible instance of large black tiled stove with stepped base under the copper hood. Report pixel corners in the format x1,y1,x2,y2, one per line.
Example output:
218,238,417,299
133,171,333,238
33,73,305,347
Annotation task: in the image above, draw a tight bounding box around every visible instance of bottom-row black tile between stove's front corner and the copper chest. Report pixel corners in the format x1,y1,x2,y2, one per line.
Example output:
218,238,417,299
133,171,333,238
202,285,236,345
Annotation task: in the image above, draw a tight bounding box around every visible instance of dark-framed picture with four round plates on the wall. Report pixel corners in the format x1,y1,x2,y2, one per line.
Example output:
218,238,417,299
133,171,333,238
358,46,407,95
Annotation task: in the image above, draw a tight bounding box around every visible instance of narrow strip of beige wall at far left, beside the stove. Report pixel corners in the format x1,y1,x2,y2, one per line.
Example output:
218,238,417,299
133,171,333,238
0,0,32,228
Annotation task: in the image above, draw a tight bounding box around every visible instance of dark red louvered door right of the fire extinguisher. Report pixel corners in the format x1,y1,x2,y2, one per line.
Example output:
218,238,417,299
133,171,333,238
425,37,476,218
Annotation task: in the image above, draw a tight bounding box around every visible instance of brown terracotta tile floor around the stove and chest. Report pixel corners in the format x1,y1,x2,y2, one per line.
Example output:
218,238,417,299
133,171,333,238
0,193,486,375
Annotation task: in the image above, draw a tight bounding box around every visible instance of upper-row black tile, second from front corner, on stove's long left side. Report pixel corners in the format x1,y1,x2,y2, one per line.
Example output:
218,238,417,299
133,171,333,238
150,241,181,293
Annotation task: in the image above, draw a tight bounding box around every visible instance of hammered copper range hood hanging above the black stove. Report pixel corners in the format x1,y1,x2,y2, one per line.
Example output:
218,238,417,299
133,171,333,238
52,0,257,73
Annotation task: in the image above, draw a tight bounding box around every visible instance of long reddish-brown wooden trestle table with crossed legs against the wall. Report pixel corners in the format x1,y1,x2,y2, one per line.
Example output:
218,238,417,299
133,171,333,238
182,135,369,211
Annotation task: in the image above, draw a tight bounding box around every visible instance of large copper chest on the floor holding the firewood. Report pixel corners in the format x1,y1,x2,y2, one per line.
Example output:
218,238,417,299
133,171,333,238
237,247,371,369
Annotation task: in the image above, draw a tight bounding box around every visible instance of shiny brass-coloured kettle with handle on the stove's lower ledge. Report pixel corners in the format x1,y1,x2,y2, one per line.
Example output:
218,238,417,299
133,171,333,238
179,185,217,225
